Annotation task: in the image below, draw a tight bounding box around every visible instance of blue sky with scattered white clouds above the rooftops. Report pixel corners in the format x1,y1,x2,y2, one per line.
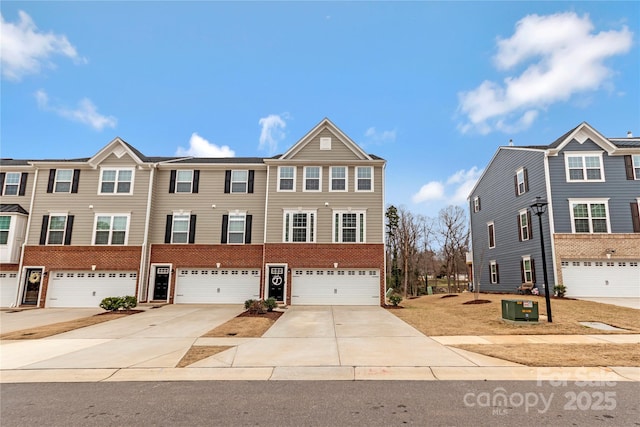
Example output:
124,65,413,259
0,1,640,216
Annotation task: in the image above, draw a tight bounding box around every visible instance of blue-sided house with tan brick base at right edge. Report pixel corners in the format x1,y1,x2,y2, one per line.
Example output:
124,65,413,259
468,123,640,297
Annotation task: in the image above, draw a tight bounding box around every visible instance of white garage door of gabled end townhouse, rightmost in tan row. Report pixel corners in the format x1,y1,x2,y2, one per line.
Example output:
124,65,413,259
291,269,380,305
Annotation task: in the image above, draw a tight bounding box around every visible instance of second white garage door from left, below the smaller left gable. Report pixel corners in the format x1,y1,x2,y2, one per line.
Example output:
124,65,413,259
46,271,138,307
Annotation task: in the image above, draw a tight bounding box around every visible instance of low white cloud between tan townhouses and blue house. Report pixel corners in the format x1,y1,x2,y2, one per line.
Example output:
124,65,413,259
411,166,482,206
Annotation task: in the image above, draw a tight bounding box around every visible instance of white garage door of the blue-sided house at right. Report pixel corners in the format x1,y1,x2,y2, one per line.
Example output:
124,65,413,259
562,261,640,298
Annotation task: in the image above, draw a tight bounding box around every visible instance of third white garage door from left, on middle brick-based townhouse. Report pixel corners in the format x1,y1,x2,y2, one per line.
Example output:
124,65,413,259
174,269,260,304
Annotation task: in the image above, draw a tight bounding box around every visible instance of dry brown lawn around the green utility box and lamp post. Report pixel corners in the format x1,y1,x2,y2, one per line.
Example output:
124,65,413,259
391,293,640,338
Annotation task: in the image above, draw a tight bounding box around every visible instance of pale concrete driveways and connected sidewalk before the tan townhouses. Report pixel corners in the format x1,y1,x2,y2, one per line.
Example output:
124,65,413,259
0,305,640,383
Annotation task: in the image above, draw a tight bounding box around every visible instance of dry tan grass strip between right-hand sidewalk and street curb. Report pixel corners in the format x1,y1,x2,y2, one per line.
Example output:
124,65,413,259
455,344,640,367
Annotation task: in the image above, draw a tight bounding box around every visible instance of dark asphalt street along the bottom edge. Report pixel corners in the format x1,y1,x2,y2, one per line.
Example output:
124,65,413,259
0,381,640,427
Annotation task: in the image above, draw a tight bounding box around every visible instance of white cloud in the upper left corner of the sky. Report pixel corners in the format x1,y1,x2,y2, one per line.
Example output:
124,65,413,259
0,11,87,81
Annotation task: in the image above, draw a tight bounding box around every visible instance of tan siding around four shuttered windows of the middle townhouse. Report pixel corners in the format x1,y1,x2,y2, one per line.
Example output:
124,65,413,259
149,164,267,244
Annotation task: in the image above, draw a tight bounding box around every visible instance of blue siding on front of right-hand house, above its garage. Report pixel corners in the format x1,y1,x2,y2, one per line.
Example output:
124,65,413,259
549,140,640,233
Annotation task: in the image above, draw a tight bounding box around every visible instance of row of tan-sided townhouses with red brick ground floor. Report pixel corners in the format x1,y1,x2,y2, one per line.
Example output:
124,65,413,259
0,119,385,307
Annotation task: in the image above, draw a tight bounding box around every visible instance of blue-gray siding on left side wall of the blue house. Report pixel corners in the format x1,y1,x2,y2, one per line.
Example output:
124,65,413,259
469,147,555,292
